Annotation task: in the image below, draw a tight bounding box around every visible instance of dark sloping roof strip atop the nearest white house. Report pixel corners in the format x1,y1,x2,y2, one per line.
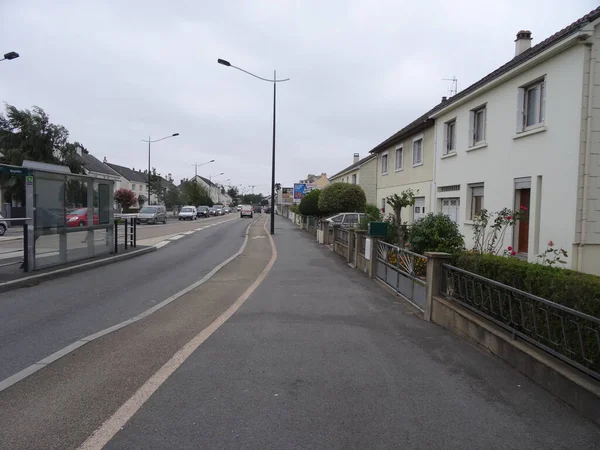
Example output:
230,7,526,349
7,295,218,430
432,7,600,114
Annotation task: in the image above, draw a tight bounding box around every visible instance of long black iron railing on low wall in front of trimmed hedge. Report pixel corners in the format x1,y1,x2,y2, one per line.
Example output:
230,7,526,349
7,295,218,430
441,264,600,380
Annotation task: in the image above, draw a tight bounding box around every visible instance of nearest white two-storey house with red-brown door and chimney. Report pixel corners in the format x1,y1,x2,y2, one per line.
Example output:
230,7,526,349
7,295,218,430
430,8,600,275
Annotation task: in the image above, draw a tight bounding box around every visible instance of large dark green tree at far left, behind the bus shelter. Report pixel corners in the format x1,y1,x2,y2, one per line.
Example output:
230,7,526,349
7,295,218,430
0,105,86,202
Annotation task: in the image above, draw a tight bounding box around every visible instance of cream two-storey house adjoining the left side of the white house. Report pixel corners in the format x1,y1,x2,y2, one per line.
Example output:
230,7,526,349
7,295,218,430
370,106,438,223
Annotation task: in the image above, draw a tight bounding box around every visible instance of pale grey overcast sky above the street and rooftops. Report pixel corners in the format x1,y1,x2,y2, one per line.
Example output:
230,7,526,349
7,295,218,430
0,0,598,193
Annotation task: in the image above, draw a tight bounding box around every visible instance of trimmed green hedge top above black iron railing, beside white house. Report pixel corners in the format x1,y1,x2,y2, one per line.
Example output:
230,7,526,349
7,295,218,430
453,253,600,317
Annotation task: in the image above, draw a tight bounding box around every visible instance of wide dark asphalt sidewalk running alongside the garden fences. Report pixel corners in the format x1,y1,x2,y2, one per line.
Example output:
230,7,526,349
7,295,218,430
106,217,600,449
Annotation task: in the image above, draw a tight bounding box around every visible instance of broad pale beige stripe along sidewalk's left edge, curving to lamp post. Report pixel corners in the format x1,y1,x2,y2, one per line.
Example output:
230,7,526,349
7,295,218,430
79,216,277,450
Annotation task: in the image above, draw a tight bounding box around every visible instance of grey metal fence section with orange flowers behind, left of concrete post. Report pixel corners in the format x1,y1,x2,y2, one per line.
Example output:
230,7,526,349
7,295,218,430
376,241,427,310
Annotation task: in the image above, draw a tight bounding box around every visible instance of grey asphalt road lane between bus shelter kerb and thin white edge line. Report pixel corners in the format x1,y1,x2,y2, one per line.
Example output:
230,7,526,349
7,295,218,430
0,215,250,382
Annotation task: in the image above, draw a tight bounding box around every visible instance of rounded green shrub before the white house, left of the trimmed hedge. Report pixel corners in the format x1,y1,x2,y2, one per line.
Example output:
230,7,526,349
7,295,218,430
407,213,465,254
